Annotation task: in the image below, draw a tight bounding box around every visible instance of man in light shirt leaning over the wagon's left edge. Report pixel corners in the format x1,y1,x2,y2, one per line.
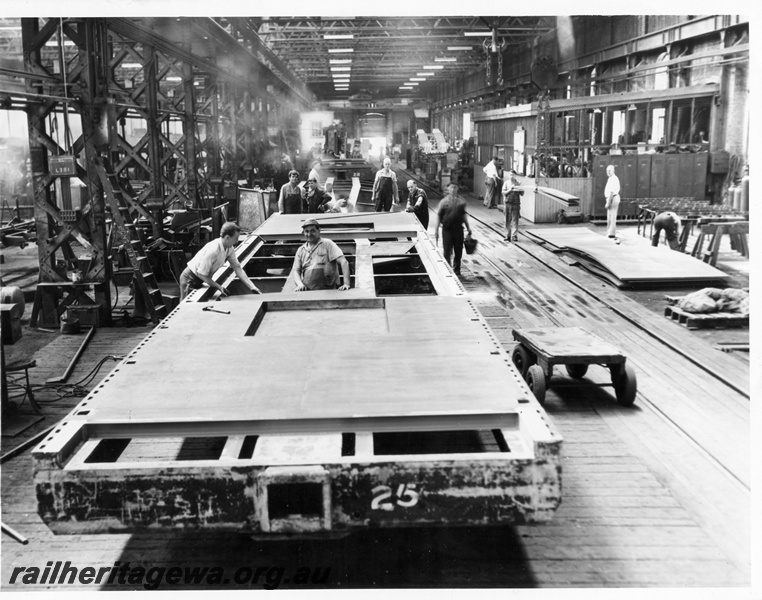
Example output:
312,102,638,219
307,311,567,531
180,223,262,300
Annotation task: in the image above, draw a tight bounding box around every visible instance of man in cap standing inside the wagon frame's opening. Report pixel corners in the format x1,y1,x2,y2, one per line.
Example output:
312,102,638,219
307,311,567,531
291,219,349,292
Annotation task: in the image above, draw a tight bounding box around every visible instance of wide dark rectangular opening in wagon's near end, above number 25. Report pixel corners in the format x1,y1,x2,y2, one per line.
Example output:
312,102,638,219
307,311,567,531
373,429,510,456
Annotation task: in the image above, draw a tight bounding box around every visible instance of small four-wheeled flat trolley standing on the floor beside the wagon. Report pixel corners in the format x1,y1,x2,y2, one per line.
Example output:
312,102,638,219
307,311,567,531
512,327,637,406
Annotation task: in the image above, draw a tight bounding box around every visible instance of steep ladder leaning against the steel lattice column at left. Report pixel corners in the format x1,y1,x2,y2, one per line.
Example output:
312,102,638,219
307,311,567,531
96,157,167,323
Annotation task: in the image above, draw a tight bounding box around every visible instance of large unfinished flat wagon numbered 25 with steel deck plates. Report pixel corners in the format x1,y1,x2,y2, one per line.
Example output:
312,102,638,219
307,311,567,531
33,213,561,536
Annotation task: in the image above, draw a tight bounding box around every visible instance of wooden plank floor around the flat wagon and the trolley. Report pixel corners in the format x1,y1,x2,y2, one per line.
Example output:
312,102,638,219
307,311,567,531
0,177,751,591
